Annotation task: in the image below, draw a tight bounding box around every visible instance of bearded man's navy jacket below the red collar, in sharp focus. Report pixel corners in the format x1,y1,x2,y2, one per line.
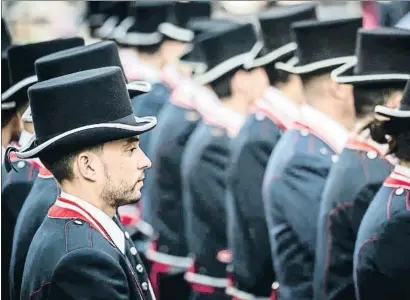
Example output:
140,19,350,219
21,218,152,300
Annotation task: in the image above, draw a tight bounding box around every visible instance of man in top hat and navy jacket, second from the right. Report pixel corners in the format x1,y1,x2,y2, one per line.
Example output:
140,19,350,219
314,28,410,300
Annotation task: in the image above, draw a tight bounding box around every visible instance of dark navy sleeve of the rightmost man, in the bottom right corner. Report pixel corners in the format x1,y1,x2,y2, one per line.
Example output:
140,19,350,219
354,211,410,300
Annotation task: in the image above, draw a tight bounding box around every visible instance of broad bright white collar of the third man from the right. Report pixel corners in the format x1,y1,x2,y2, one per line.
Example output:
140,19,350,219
300,104,349,153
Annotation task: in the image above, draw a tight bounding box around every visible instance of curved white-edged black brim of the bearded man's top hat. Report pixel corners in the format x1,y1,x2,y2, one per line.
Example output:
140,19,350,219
16,114,157,159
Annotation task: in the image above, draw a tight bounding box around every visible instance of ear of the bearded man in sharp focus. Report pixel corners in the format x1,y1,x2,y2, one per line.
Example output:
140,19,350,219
73,151,101,182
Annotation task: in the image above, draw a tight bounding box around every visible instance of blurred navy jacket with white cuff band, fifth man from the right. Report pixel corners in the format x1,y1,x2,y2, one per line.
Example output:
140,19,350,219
181,106,242,295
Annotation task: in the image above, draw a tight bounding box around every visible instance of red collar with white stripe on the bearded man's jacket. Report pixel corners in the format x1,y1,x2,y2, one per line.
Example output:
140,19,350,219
47,196,115,246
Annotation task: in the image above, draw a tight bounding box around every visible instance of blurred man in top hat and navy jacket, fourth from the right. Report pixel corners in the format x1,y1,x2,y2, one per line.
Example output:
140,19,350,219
227,4,316,300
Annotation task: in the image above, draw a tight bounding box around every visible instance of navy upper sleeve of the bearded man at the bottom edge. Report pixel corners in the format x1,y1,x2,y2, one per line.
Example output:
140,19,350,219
47,248,129,300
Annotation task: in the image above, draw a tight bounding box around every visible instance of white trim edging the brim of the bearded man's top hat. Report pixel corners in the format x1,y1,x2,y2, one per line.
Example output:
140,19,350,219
16,116,157,159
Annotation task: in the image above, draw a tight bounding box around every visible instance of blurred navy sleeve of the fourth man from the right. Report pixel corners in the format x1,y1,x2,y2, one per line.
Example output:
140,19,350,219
228,137,278,286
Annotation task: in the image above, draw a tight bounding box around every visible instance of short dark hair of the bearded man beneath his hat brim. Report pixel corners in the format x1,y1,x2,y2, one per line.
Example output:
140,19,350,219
40,145,103,183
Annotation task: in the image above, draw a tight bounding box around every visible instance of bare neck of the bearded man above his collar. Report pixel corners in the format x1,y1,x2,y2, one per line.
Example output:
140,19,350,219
61,182,116,218
